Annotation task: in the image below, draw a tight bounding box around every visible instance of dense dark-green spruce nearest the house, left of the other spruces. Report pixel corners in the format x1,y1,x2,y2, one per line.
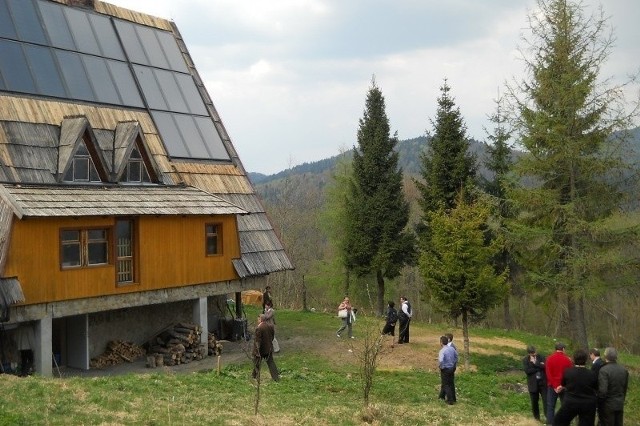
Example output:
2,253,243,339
343,80,414,314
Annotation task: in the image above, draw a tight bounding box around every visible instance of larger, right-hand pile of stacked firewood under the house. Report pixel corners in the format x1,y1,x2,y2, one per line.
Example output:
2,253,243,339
147,323,222,368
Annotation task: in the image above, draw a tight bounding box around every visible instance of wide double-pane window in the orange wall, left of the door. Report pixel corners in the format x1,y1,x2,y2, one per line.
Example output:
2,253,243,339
60,229,109,268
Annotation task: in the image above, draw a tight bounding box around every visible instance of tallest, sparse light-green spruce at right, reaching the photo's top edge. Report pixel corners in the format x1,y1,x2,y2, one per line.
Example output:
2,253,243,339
512,0,638,347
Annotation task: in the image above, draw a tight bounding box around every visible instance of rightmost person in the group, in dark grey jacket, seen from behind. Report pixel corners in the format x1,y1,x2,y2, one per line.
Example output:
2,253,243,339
598,347,629,426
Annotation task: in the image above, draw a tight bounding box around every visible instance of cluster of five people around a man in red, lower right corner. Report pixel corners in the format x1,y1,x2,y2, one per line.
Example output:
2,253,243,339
522,342,629,426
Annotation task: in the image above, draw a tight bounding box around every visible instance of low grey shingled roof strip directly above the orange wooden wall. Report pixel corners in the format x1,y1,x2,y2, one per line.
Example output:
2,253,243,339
0,185,247,219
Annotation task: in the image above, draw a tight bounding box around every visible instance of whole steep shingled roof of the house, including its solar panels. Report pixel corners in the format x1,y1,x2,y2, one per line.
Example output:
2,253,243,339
0,0,293,277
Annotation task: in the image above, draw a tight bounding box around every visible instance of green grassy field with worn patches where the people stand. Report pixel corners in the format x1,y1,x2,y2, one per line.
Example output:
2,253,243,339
0,309,640,426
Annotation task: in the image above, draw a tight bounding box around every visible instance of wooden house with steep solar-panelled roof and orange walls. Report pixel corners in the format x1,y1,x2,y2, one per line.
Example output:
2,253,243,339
0,0,293,375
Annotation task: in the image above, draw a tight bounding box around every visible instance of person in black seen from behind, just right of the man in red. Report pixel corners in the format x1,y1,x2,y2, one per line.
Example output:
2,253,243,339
553,349,598,426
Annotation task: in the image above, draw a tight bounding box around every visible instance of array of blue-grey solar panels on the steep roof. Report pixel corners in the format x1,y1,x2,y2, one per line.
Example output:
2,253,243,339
0,0,230,161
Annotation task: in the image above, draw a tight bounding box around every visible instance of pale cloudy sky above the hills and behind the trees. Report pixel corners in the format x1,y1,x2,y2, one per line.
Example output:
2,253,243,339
106,0,640,174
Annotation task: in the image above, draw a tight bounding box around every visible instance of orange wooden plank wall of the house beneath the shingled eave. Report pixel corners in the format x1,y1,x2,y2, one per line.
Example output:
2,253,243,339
4,215,240,304
